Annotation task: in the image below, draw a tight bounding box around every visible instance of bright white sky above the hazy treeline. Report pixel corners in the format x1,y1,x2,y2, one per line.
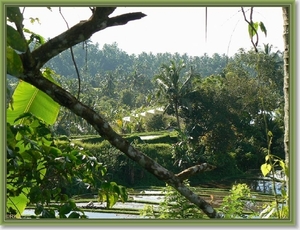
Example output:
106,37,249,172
24,6,283,56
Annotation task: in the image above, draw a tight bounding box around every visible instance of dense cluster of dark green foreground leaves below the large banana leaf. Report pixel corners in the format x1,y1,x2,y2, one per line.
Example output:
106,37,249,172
6,113,110,218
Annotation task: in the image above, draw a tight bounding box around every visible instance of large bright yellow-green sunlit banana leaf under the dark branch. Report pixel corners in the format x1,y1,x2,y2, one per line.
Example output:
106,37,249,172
7,81,60,125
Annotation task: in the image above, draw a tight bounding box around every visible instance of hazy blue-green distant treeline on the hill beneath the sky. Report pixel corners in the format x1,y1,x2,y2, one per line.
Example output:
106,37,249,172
47,42,231,79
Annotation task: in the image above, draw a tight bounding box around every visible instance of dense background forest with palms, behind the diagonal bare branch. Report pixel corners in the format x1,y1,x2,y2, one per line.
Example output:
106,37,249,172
30,43,284,186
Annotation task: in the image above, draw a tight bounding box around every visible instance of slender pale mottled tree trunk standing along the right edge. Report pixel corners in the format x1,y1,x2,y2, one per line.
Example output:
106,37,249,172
282,7,290,191
